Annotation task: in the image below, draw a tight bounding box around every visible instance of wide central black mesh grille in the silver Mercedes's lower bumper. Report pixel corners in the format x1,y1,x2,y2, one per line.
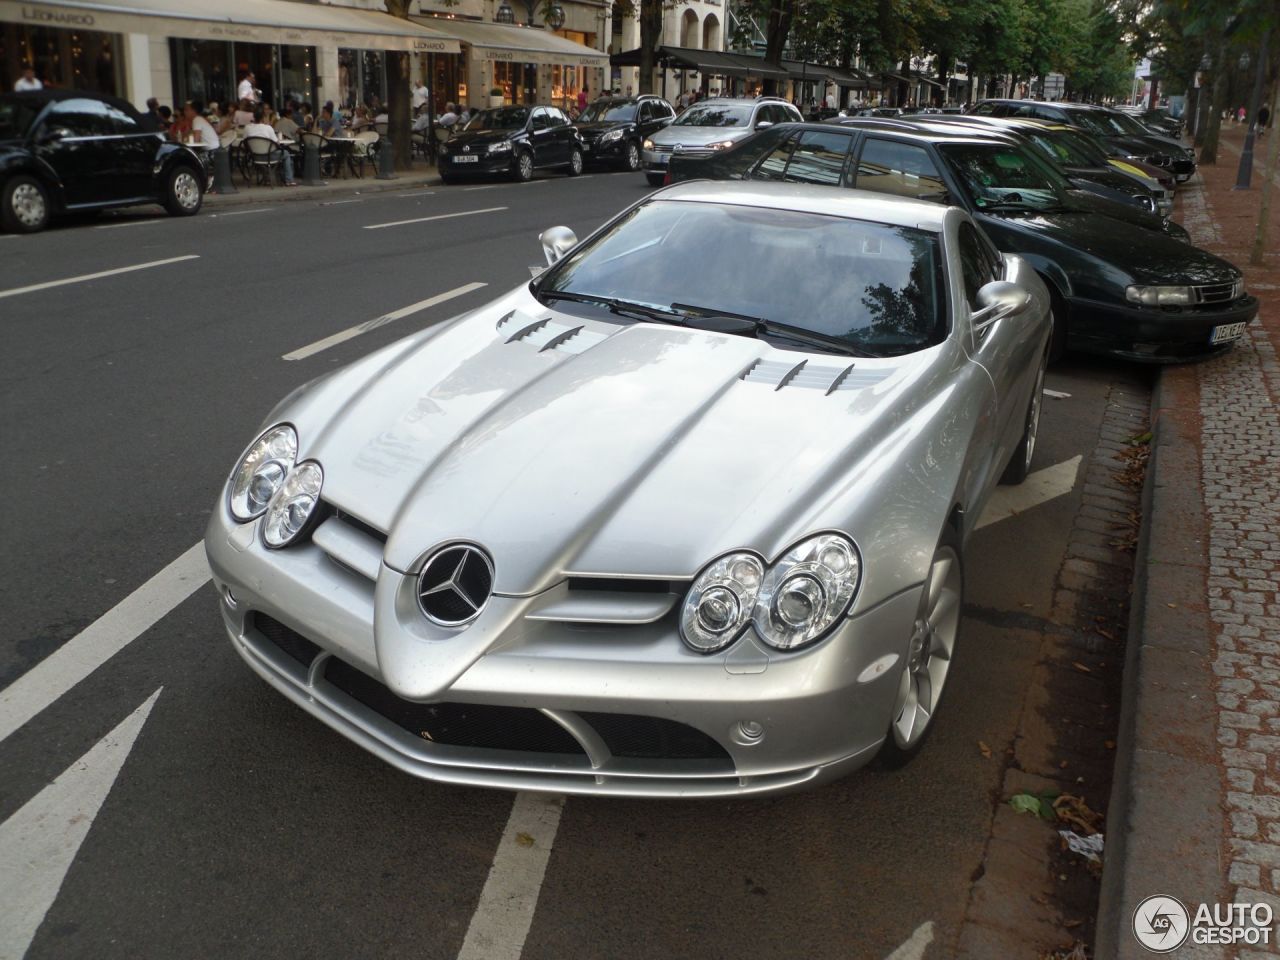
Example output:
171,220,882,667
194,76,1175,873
324,657,585,756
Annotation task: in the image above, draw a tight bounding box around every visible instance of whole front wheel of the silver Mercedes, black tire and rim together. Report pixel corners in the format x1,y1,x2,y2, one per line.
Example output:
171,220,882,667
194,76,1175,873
876,525,964,769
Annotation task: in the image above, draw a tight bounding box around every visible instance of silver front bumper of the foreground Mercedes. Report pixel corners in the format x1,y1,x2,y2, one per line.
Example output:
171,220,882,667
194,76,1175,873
205,507,919,797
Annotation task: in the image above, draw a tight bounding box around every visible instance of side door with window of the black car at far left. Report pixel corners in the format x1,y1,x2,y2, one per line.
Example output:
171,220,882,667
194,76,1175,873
35,97,125,207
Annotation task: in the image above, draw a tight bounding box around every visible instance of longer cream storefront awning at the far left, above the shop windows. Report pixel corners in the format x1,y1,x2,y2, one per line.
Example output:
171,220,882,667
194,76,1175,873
0,0,458,54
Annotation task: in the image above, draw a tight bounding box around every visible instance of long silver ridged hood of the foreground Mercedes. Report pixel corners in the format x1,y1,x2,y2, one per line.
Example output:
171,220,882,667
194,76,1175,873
290,288,947,595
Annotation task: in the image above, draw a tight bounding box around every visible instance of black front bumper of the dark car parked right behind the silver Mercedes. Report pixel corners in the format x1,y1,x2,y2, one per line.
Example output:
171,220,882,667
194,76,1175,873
1068,296,1258,362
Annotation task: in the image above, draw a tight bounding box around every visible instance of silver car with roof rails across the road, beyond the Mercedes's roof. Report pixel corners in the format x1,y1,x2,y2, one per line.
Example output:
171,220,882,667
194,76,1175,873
640,97,804,187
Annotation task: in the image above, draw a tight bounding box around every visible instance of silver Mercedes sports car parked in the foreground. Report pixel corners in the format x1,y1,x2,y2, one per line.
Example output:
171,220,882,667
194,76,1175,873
206,182,1051,796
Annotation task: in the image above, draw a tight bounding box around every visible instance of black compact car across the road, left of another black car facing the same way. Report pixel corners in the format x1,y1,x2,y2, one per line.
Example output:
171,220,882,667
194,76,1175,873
438,105,584,183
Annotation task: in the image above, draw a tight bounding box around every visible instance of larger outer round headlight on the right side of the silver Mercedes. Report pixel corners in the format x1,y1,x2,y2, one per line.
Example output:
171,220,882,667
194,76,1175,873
751,534,861,650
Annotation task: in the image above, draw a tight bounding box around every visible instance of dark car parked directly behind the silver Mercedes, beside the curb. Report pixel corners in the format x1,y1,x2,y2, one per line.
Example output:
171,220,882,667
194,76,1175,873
671,120,1258,361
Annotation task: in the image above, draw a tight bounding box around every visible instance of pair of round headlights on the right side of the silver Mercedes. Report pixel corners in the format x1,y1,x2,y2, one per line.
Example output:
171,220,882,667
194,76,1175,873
680,534,860,653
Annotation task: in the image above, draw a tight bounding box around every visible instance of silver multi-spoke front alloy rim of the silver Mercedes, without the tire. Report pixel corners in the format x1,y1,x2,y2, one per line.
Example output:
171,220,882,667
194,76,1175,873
891,545,961,750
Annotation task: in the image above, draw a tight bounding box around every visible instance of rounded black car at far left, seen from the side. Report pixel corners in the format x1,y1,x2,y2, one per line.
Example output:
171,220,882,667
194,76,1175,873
0,90,209,233
